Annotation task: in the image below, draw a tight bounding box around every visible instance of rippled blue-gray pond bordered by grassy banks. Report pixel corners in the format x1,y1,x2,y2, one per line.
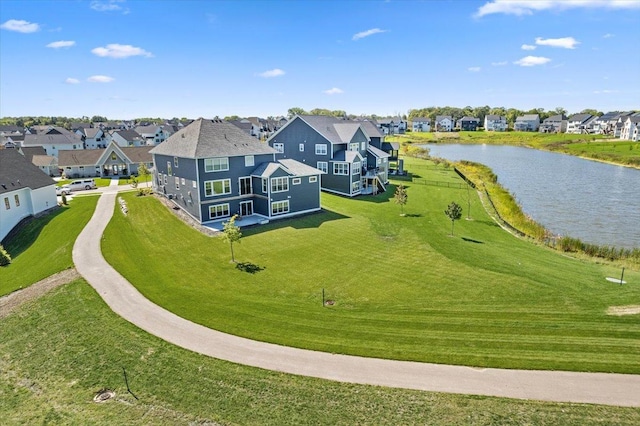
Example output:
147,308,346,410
424,144,640,248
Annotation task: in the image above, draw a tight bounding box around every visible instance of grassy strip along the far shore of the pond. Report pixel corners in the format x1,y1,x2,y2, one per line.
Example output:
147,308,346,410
386,131,640,167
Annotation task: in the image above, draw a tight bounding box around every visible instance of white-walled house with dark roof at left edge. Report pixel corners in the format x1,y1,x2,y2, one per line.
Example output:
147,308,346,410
0,149,57,241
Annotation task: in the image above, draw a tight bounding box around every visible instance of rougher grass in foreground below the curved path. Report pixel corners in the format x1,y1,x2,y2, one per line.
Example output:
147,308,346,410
0,280,640,426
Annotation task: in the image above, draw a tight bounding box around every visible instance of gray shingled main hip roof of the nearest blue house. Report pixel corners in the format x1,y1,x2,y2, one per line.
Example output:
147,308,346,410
151,118,276,158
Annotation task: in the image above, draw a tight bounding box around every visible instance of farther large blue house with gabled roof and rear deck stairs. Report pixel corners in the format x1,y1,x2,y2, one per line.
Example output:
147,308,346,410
267,115,390,197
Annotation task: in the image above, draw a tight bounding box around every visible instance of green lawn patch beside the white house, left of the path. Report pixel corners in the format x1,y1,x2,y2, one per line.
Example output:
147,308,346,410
0,197,98,296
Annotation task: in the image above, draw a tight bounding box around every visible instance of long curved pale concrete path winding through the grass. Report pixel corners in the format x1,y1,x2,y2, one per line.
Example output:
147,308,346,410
73,191,640,407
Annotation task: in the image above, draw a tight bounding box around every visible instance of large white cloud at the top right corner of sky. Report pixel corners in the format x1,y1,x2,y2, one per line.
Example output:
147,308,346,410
474,0,640,18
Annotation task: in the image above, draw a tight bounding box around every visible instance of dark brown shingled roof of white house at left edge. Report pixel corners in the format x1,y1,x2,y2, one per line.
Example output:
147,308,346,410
0,149,55,194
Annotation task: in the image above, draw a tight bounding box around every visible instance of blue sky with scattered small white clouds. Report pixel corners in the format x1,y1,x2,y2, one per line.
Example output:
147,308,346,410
0,0,640,119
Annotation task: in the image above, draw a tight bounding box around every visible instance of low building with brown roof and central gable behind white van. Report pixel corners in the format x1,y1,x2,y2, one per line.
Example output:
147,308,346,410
58,141,153,178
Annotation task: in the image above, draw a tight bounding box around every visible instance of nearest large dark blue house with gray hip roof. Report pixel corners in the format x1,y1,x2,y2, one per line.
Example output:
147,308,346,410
150,118,321,223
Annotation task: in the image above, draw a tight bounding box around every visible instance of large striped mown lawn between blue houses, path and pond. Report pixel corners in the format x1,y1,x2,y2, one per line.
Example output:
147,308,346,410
102,159,640,373
